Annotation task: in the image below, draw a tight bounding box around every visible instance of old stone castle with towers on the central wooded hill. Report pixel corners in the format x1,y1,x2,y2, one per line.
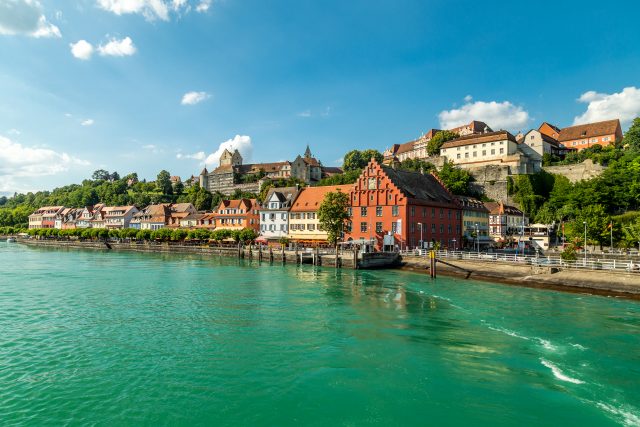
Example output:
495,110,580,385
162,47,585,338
199,145,342,195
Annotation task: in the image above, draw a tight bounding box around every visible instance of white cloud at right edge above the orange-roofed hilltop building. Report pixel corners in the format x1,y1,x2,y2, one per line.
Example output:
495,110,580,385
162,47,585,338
573,86,640,127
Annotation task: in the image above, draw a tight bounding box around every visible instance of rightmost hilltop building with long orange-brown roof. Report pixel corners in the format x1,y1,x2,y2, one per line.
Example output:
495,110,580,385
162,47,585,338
558,119,622,150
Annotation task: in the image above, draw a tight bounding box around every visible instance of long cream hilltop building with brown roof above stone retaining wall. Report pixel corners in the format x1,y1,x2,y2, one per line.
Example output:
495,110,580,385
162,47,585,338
440,130,542,175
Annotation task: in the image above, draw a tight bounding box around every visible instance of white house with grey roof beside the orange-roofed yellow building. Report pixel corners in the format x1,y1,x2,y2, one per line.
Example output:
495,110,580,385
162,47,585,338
260,186,300,240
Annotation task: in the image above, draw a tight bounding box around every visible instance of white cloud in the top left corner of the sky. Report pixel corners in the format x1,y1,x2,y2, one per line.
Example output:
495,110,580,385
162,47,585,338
0,0,61,38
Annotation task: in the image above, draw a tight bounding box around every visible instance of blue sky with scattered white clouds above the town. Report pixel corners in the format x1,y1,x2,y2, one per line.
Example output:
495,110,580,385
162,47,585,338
0,0,640,195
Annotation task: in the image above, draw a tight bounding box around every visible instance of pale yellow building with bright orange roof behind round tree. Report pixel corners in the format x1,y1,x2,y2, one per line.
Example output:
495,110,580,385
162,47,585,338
289,184,353,244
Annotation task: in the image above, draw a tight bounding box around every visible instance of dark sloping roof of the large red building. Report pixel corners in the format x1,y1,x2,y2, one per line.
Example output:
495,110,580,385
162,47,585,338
380,165,456,204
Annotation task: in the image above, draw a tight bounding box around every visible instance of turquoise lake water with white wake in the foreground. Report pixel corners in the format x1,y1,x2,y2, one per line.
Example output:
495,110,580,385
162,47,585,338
0,243,640,426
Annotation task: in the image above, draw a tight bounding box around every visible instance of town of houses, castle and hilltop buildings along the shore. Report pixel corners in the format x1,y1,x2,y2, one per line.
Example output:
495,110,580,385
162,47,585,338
16,115,640,251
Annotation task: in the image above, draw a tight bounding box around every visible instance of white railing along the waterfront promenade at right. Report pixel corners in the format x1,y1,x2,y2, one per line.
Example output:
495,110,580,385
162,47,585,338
401,249,640,273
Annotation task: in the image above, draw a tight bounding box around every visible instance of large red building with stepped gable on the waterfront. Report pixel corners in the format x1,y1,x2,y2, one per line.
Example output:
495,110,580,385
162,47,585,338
345,159,462,249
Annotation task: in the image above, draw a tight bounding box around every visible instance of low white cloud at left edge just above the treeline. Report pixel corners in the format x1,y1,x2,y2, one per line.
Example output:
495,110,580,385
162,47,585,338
0,136,90,191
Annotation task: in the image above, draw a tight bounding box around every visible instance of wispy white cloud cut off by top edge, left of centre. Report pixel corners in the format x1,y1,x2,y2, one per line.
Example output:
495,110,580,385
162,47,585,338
97,0,211,21
